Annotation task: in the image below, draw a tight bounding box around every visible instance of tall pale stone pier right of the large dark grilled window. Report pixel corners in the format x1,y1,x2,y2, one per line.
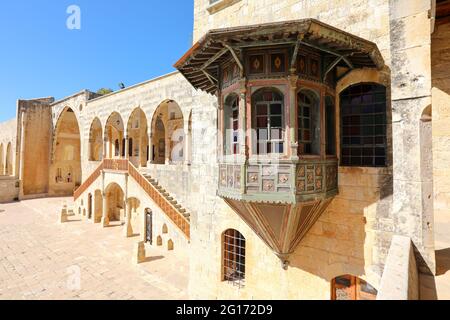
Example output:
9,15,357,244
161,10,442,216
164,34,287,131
390,0,435,273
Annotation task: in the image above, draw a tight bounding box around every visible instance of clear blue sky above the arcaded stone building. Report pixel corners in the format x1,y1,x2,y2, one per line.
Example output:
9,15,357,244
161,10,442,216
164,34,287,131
0,0,193,122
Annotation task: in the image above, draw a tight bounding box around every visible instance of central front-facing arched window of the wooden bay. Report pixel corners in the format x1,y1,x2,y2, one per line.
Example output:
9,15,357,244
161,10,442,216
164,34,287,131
252,88,285,155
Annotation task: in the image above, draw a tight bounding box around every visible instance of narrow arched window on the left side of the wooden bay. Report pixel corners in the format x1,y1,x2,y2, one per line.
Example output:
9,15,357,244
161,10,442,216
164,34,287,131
224,94,239,155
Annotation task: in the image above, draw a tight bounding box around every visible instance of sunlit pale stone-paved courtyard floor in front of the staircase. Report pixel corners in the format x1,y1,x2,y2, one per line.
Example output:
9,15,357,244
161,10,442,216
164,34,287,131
0,198,189,300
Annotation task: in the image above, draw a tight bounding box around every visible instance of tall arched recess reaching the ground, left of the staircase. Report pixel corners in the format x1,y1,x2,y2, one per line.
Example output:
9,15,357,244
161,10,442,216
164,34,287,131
50,108,82,196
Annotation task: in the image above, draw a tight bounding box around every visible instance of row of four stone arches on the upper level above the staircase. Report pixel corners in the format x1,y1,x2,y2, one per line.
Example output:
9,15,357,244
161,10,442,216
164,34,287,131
89,100,192,168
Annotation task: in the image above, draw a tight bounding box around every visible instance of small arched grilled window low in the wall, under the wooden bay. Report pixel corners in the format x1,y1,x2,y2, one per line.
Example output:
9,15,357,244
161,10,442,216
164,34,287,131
223,229,245,287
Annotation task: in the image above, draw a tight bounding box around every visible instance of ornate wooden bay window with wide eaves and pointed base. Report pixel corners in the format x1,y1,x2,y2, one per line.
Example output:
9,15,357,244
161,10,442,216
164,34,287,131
175,19,384,266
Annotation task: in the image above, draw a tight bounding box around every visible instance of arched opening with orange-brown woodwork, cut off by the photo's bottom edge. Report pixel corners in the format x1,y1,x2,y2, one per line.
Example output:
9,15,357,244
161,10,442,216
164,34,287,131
331,275,378,300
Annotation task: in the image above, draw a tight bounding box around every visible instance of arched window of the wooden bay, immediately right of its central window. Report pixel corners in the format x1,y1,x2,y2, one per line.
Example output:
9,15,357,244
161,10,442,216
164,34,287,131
297,90,321,155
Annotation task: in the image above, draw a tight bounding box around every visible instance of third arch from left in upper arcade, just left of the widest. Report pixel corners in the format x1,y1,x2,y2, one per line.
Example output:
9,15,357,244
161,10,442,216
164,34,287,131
127,108,149,168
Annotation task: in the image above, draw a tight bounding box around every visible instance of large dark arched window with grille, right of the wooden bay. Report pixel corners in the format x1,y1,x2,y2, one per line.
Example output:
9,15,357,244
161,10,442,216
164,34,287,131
340,83,387,167
